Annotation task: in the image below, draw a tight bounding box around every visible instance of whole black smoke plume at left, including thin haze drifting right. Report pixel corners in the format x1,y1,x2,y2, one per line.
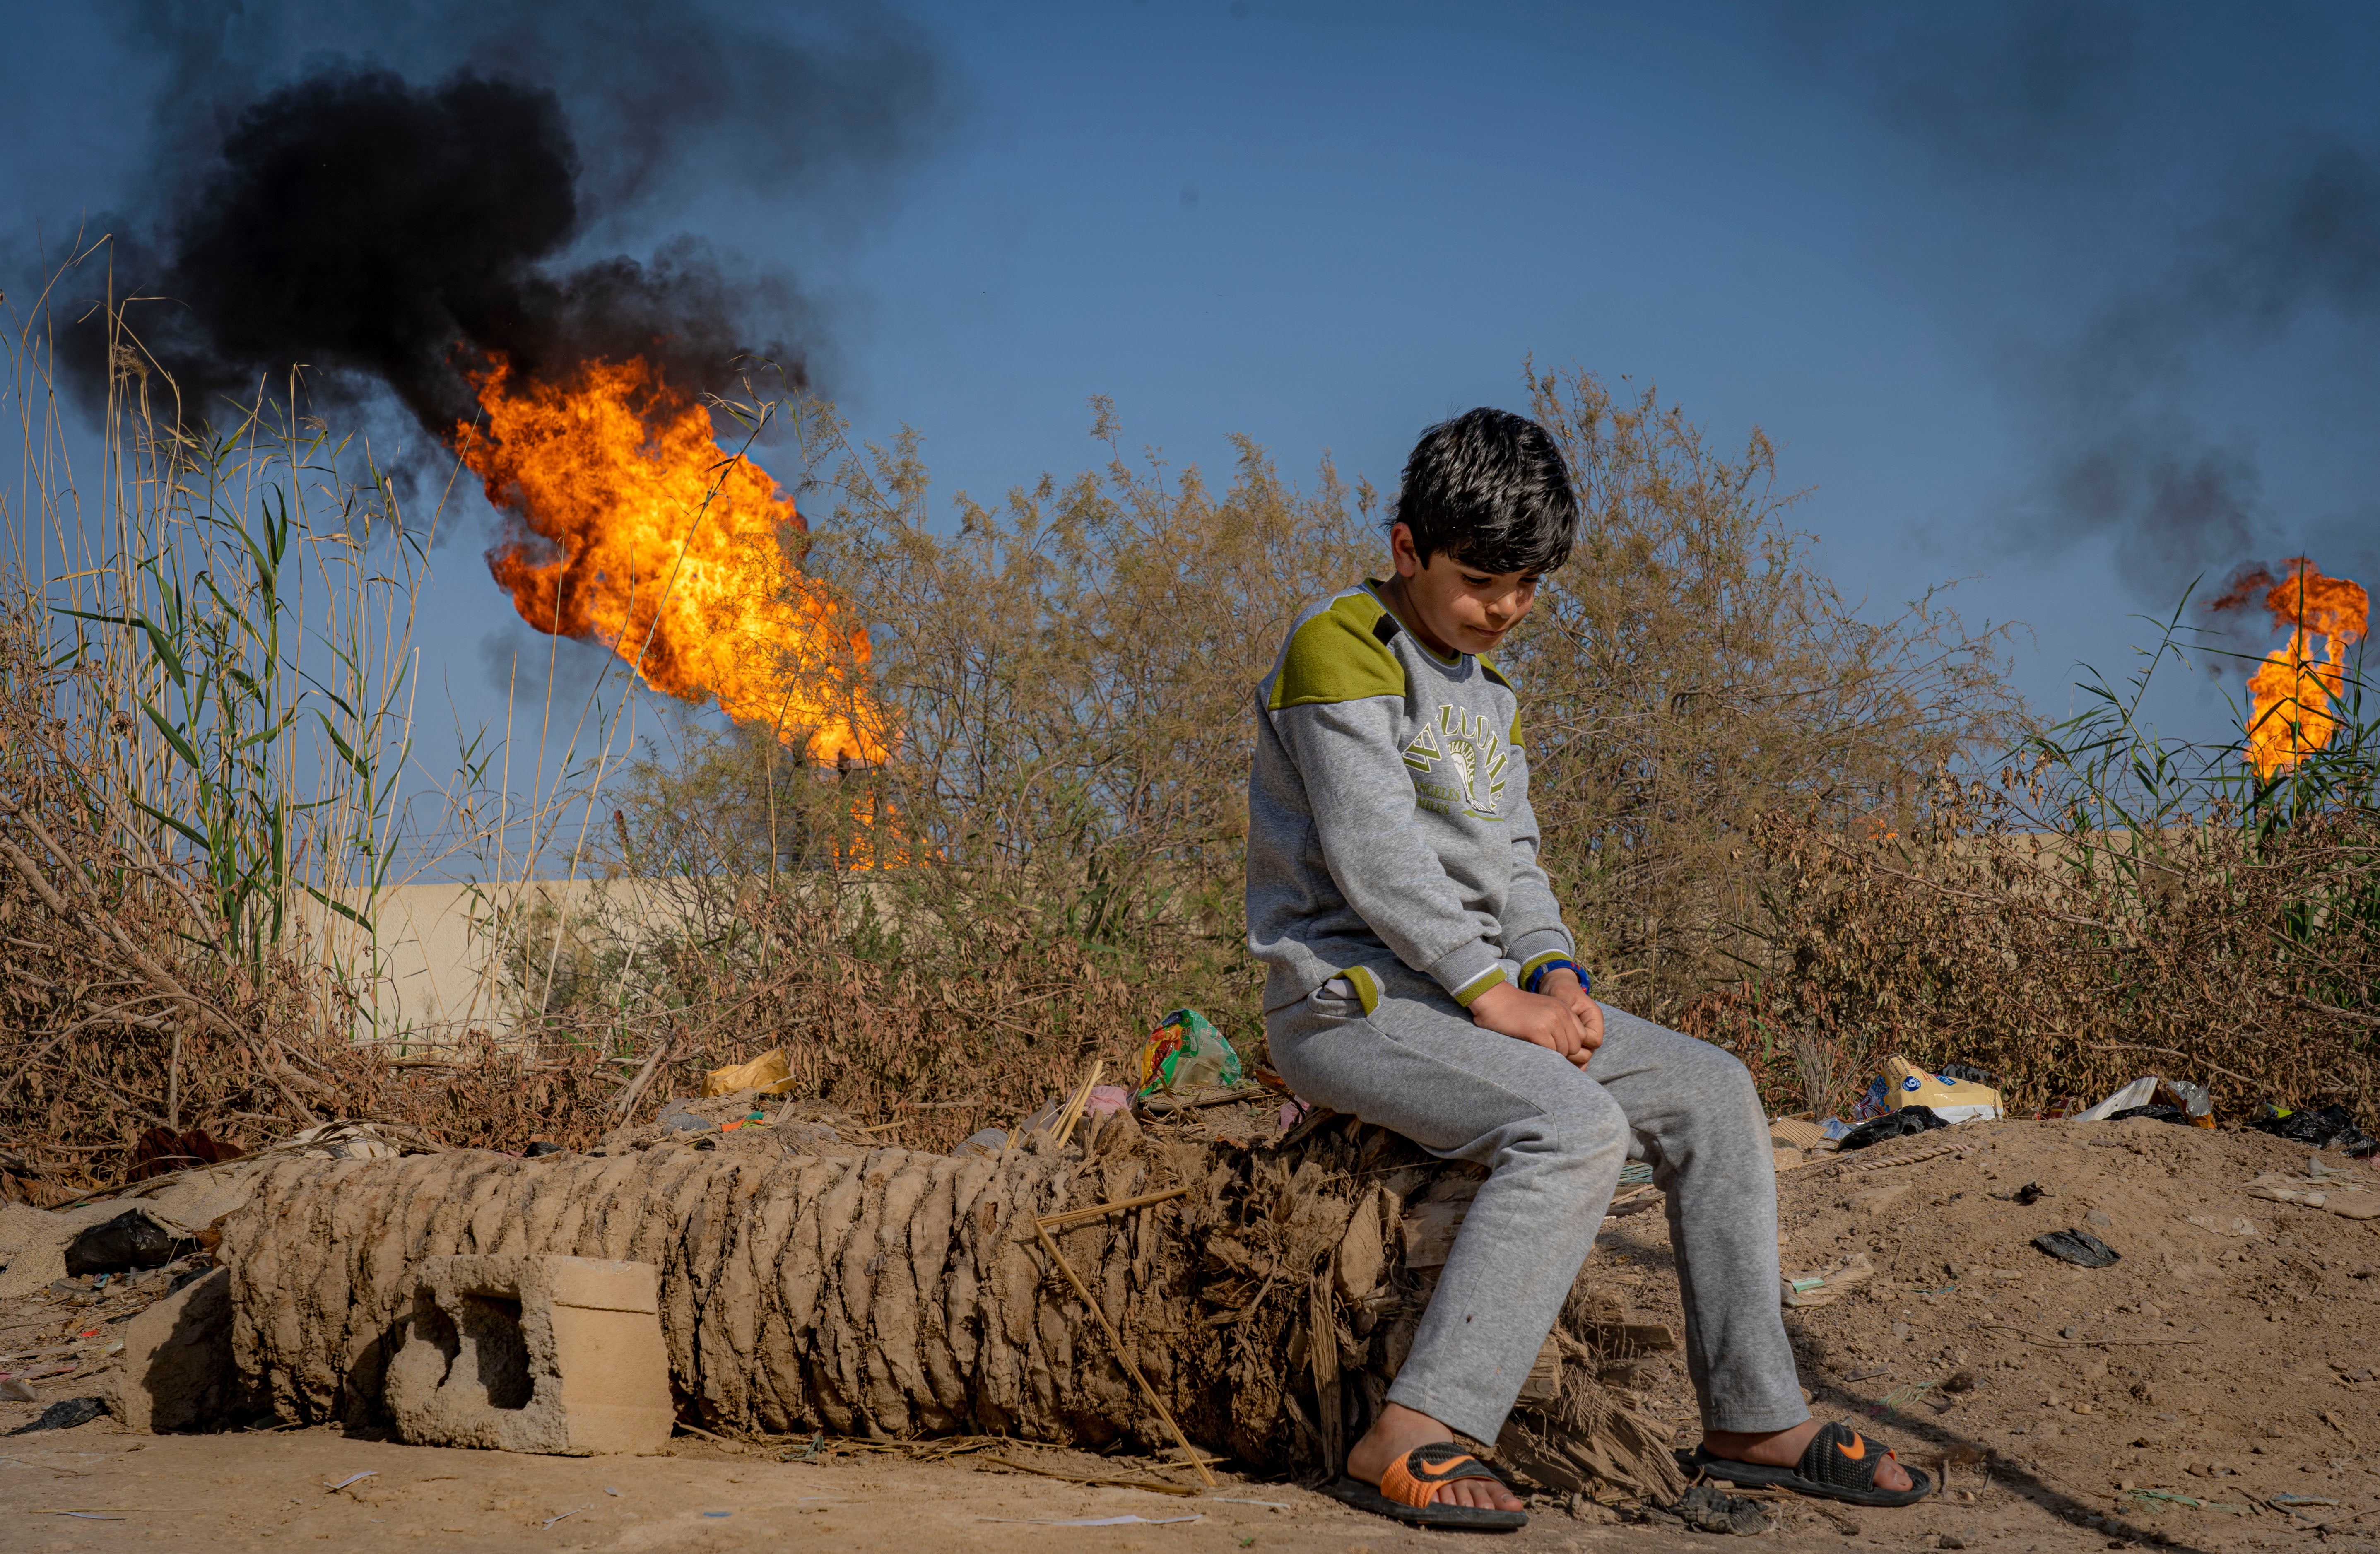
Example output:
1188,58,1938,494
67,0,940,452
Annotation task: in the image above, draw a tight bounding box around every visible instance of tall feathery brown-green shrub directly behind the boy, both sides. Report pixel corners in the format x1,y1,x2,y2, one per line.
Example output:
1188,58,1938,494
561,373,2014,1123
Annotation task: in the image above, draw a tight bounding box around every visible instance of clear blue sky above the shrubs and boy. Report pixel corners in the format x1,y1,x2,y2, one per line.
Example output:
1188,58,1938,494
0,0,2380,871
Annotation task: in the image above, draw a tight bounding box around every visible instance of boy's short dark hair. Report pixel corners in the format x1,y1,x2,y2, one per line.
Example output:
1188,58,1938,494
1392,405,1578,571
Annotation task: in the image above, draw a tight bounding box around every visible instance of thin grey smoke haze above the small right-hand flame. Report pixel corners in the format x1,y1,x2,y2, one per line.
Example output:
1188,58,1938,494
1785,0,2380,645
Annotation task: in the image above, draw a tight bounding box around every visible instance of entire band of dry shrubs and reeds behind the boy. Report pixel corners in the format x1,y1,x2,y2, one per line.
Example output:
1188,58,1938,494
0,257,2380,1192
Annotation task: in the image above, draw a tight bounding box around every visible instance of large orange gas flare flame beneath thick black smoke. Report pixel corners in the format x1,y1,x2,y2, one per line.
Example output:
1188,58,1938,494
455,357,885,764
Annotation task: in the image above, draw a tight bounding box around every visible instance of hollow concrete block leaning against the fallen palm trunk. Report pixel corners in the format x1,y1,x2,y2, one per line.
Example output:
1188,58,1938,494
385,1257,676,1456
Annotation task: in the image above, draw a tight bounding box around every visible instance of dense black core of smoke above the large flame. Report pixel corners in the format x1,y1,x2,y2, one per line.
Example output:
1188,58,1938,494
117,71,785,436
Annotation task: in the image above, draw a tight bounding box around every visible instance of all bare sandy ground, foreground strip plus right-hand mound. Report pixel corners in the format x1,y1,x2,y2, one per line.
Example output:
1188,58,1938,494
0,1121,2380,1554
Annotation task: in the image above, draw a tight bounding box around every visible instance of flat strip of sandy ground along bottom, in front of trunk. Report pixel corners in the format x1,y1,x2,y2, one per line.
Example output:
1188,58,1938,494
0,1421,2247,1554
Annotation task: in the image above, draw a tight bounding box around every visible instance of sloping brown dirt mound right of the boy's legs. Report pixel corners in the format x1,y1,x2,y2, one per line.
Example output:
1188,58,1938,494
1587,1118,2380,1547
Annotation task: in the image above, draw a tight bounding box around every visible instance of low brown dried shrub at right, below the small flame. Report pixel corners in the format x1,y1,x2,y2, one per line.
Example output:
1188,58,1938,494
1690,633,2380,1123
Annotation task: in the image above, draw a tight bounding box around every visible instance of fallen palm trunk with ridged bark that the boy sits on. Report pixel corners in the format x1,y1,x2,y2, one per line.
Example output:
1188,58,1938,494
224,1118,1676,1490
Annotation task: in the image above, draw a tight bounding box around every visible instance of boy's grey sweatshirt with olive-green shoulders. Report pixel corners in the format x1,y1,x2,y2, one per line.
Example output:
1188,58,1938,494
1247,583,1573,1014
